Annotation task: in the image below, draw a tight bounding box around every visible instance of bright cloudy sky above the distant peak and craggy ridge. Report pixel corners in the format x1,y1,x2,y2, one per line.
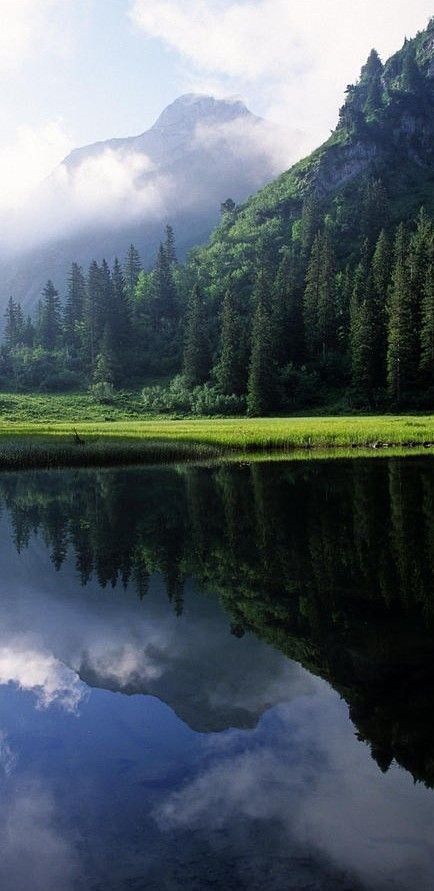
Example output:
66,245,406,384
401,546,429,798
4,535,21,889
0,0,433,209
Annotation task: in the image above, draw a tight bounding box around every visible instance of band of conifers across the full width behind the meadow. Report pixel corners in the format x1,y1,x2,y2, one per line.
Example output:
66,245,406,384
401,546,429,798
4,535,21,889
0,201,434,415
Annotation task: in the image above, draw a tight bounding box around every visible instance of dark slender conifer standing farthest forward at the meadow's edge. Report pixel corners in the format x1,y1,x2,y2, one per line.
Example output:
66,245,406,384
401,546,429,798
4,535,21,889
247,269,276,416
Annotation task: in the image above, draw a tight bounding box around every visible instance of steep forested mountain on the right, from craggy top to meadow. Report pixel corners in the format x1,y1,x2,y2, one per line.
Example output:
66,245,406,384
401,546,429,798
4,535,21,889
176,18,434,415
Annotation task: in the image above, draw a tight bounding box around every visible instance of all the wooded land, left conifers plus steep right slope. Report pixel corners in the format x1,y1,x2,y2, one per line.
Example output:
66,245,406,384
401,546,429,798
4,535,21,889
0,20,434,415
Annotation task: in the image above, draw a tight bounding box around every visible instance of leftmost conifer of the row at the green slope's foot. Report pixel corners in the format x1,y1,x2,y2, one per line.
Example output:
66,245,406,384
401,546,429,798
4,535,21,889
183,285,211,388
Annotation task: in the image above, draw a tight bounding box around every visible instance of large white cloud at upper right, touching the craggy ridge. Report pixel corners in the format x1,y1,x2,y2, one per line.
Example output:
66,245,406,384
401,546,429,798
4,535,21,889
130,0,432,151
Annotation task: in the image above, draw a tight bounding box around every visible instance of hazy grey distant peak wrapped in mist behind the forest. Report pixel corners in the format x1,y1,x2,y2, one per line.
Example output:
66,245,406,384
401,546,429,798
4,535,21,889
0,93,276,309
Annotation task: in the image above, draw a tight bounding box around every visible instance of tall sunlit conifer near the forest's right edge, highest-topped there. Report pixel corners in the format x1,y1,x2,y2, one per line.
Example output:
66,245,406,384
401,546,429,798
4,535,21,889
387,224,415,404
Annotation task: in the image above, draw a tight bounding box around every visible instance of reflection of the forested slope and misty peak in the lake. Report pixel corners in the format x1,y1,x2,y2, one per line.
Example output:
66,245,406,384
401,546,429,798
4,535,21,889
0,458,434,786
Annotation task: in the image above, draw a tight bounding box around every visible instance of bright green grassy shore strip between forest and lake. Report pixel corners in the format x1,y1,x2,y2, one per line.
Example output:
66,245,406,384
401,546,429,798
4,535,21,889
0,415,434,470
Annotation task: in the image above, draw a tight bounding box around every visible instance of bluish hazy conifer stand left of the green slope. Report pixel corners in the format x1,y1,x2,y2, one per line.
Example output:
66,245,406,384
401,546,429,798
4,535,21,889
0,226,182,397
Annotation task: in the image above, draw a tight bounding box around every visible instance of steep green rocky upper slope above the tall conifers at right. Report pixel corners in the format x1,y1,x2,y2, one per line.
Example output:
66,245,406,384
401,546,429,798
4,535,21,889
195,19,434,295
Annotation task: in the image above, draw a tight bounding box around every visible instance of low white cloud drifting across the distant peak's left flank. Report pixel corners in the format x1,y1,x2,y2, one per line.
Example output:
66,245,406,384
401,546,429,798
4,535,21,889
0,145,174,250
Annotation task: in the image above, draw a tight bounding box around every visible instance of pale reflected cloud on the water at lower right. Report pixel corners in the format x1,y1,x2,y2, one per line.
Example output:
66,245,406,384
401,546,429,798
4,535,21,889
155,688,434,891
